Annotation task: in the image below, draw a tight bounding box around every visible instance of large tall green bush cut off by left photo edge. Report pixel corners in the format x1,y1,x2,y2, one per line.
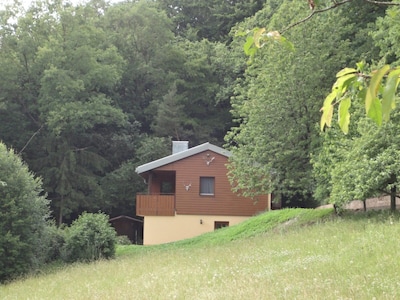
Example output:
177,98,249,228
0,143,50,282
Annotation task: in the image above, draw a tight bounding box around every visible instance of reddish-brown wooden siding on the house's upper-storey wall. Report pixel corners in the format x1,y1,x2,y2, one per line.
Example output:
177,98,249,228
153,150,269,216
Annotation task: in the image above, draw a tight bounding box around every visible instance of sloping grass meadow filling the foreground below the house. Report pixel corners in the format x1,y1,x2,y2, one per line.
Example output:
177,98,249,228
0,209,400,299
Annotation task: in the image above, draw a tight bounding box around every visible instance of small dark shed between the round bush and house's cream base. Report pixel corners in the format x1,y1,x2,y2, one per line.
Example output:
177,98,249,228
109,215,143,244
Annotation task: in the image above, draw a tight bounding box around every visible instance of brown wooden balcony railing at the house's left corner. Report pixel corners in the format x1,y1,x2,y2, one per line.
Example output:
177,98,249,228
136,194,175,216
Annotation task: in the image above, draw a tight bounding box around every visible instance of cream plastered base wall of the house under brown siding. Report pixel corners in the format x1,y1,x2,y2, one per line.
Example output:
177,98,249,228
143,215,249,245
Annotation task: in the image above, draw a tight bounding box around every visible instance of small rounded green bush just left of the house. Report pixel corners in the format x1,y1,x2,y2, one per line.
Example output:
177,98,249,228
62,213,117,262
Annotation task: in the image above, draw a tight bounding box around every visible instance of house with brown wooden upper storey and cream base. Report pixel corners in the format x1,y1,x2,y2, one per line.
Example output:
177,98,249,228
136,141,271,245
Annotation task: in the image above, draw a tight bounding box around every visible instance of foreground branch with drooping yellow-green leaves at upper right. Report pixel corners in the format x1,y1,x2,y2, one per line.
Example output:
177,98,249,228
244,0,400,133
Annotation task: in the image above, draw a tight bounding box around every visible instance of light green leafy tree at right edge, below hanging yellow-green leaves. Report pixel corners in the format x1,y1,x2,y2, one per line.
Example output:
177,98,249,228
316,112,400,210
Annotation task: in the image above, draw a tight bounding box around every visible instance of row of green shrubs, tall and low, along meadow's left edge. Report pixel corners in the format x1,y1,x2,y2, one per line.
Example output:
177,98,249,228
0,142,116,283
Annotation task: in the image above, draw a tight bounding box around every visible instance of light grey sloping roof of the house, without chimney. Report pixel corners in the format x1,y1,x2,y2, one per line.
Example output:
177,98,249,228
136,143,231,174
